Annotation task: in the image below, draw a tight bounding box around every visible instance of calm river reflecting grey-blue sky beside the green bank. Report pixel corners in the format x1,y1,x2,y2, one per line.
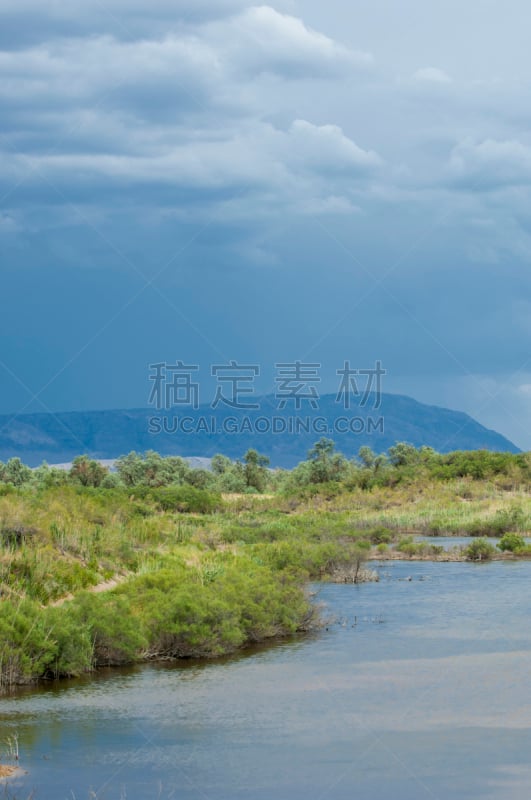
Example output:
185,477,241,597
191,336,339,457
0,562,531,800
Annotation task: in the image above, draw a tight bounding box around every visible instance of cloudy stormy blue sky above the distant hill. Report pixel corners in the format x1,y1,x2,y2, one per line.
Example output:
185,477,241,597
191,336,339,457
0,0,531,449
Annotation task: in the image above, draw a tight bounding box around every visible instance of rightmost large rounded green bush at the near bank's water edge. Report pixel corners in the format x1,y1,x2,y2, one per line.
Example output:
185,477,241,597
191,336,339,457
119,557,309,658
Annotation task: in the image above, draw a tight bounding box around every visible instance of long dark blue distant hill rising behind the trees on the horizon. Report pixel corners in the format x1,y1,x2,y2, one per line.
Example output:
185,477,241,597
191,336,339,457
0,394,518,467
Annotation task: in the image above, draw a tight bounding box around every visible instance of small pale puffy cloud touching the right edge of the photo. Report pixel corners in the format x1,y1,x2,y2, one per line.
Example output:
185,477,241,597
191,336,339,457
448,139,531,191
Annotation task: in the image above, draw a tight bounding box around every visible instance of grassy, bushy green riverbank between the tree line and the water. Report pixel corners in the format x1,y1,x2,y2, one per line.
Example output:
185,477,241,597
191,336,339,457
0,472,531,689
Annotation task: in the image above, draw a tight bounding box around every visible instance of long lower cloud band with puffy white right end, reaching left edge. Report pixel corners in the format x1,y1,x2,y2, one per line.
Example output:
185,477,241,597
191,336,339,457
4,120,382,203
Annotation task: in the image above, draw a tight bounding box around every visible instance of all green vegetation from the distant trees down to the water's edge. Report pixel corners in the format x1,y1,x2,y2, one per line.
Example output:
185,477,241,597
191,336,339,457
0,439,531,688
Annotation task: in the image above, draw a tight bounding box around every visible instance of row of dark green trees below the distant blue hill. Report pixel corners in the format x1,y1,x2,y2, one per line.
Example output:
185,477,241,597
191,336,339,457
0,438,531,496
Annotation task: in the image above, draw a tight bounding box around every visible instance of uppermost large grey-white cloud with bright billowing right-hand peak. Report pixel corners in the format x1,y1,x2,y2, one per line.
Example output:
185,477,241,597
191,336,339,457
0,5,370,142
